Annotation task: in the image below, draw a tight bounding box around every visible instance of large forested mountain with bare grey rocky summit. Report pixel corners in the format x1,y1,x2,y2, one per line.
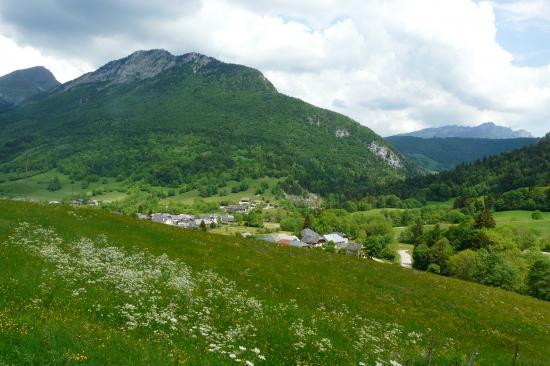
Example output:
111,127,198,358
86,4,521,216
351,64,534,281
0,50,417,197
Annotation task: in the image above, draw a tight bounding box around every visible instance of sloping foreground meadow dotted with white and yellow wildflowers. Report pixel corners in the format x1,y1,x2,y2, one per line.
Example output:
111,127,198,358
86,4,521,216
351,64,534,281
0,201,550,365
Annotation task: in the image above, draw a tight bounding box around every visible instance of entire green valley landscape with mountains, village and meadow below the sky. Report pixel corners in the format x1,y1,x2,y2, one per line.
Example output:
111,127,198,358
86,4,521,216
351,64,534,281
0,49,550,366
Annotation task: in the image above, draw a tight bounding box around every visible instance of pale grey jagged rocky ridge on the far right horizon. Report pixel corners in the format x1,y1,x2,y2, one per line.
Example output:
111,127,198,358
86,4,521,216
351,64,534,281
397,122,533,139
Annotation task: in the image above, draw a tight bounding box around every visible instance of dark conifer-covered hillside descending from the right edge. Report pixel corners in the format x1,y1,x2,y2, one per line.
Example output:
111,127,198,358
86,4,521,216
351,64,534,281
396,134,550,203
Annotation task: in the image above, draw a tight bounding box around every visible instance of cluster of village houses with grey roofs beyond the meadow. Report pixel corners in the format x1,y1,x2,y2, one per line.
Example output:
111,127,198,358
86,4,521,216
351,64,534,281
138,197,365,257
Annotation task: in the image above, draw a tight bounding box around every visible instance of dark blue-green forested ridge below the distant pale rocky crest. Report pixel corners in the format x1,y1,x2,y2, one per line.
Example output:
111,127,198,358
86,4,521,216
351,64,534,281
386,136,538,171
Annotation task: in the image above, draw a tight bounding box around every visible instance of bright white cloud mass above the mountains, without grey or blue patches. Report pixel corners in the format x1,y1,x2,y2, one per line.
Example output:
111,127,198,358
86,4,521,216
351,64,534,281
0,0,550,135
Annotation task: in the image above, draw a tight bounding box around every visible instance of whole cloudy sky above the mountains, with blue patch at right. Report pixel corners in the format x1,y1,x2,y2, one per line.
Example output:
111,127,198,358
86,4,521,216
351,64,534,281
0,0,550,136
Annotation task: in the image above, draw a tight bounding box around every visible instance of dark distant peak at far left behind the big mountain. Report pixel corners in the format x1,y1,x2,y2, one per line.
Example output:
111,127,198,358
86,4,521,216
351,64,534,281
0,66,59,111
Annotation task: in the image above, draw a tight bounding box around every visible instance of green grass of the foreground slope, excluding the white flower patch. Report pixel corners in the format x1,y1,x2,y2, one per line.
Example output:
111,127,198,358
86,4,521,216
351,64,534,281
0,201,550,365
